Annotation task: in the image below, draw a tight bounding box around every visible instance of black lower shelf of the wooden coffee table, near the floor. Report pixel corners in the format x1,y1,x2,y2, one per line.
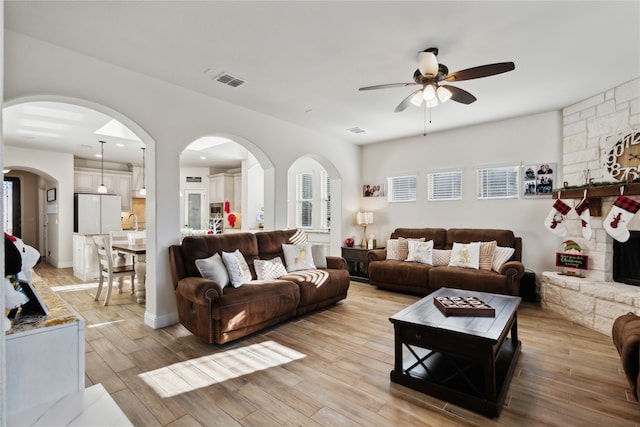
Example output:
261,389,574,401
391,338,521,418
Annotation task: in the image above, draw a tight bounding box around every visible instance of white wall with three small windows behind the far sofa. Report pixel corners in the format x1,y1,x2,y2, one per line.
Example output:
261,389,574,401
362,112,562,273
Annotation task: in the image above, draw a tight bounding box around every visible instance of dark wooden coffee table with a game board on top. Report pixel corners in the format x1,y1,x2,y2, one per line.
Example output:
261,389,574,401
389,288,521,417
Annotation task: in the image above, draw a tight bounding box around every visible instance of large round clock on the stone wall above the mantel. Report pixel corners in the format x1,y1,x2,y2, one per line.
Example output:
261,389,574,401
604,130,640,181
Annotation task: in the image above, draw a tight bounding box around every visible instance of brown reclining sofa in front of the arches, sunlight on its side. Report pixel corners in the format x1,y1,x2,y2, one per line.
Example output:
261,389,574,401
169,230,349,344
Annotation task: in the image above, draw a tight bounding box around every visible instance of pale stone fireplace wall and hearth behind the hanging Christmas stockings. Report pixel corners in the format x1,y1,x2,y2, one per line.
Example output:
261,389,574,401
540,78,640,335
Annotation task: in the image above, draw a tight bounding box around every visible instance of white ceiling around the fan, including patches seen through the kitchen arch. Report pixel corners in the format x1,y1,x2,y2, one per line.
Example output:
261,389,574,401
4,1,640,168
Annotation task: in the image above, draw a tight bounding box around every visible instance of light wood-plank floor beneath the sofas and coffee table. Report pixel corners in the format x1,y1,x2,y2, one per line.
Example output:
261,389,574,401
36,263,640,427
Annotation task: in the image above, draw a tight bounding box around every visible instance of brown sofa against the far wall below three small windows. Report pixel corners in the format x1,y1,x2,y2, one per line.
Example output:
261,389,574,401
367,228,524,296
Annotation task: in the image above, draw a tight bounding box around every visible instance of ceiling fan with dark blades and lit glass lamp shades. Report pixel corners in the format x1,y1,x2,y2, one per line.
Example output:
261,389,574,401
359,47,515,113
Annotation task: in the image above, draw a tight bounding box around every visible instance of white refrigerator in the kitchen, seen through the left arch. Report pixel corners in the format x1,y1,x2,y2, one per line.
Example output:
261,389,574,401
73,193,122,234
